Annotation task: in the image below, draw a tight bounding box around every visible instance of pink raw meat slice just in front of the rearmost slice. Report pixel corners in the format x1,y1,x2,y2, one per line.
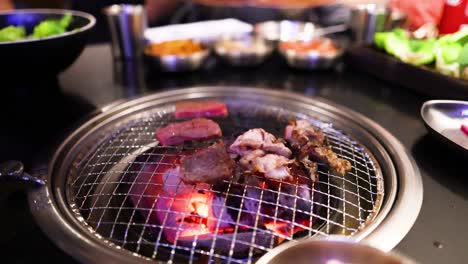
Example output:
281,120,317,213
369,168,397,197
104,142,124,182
156,118,222,146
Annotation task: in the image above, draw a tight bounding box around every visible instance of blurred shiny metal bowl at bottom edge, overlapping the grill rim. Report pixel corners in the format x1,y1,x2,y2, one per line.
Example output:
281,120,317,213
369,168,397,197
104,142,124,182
257,239,416,264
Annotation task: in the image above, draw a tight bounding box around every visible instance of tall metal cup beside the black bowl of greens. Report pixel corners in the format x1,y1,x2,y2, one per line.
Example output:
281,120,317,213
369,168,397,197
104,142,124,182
104,4,147,59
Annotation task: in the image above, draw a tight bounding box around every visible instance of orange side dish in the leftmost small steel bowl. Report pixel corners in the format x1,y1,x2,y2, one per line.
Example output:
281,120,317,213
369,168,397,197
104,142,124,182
145,40,203,56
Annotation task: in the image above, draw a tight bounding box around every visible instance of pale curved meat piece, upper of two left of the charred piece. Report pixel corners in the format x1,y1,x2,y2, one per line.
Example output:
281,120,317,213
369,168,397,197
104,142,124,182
229,128,292,158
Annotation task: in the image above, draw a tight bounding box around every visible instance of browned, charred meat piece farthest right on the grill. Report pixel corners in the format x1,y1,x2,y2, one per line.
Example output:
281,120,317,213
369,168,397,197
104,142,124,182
284,120,351,175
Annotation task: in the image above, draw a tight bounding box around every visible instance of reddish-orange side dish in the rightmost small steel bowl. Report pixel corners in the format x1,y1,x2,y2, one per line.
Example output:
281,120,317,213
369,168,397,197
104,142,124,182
281,38,338,55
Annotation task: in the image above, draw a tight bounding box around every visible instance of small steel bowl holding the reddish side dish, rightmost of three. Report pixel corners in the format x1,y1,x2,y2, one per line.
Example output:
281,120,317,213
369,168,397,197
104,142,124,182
278,39,344,70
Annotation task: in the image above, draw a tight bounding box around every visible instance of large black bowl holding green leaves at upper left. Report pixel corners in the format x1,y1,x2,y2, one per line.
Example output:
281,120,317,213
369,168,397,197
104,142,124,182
0,9,96,78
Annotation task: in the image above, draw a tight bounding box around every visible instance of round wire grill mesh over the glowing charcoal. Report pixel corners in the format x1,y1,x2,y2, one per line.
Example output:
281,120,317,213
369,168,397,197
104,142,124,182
68,101,383,263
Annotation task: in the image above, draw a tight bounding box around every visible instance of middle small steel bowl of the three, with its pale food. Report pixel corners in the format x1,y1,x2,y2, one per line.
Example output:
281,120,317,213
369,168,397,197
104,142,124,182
214,36,273,66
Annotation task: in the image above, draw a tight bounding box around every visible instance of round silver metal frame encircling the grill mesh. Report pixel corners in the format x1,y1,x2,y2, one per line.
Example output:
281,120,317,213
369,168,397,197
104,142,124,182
30,87,422,263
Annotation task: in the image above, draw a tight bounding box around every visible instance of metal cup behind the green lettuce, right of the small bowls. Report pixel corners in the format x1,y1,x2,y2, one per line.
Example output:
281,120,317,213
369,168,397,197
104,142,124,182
349,4,391,44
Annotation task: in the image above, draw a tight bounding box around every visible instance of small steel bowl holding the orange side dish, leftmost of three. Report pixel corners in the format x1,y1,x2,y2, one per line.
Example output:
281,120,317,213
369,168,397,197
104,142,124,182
144,49,210,72
